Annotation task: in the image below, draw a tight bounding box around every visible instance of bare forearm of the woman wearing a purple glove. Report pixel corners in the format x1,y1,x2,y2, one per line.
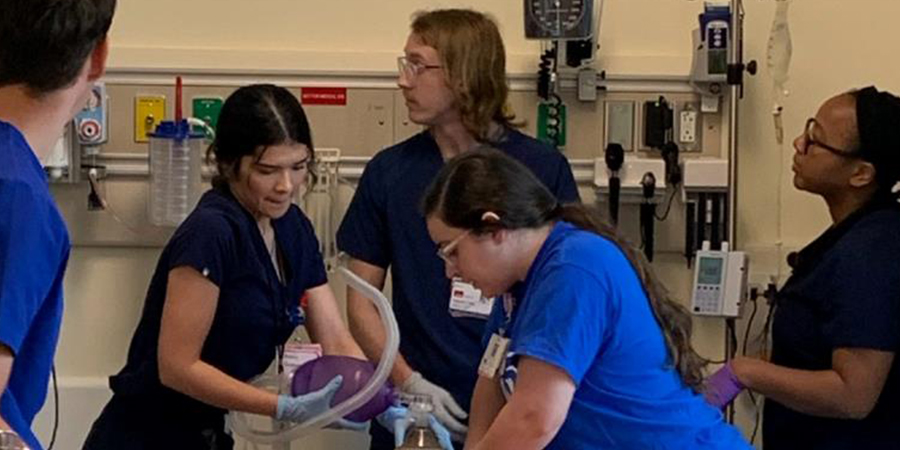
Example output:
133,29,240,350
733,348,894,419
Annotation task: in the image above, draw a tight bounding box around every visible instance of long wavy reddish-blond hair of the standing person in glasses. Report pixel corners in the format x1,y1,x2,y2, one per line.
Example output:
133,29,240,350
411,9,515,142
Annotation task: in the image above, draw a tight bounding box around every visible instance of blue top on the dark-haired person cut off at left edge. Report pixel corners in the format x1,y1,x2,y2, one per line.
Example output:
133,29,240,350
0,121,71,450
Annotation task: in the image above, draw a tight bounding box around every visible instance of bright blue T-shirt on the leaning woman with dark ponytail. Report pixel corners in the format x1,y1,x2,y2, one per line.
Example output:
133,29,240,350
485,222,750,450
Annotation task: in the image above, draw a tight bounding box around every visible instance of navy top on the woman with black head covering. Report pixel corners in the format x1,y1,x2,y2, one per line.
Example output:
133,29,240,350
763,201,900,450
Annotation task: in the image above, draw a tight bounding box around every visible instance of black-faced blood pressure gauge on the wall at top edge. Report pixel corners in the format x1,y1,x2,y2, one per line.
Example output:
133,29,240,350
525,0,594,39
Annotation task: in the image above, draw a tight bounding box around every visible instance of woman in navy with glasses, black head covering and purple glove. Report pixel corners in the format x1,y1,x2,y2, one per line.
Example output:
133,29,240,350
731,87,900,450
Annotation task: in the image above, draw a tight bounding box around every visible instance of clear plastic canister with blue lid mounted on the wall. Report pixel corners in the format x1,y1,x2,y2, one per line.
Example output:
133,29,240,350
148,120,205,226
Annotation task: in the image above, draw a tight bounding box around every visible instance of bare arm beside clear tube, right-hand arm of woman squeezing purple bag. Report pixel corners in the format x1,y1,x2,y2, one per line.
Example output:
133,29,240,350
306,284,365,358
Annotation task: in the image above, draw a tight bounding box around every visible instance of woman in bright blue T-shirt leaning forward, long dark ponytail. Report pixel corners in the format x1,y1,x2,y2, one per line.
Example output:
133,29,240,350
423,150,749,450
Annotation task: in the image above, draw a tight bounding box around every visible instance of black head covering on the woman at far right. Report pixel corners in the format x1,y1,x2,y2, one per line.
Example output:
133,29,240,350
856,86,900,189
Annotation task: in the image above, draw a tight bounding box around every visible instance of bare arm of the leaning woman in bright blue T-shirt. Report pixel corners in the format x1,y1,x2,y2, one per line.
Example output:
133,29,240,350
466,357,575,450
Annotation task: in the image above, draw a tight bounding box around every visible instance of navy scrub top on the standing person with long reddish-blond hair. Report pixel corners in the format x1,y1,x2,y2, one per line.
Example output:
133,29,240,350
337,129,578,410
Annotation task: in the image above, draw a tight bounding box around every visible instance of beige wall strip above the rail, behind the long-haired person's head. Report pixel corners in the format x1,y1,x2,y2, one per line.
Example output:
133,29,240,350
112,0,702,73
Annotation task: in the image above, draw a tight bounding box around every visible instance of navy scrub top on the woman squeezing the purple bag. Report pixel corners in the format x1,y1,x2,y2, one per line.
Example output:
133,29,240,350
110,188,327,421
